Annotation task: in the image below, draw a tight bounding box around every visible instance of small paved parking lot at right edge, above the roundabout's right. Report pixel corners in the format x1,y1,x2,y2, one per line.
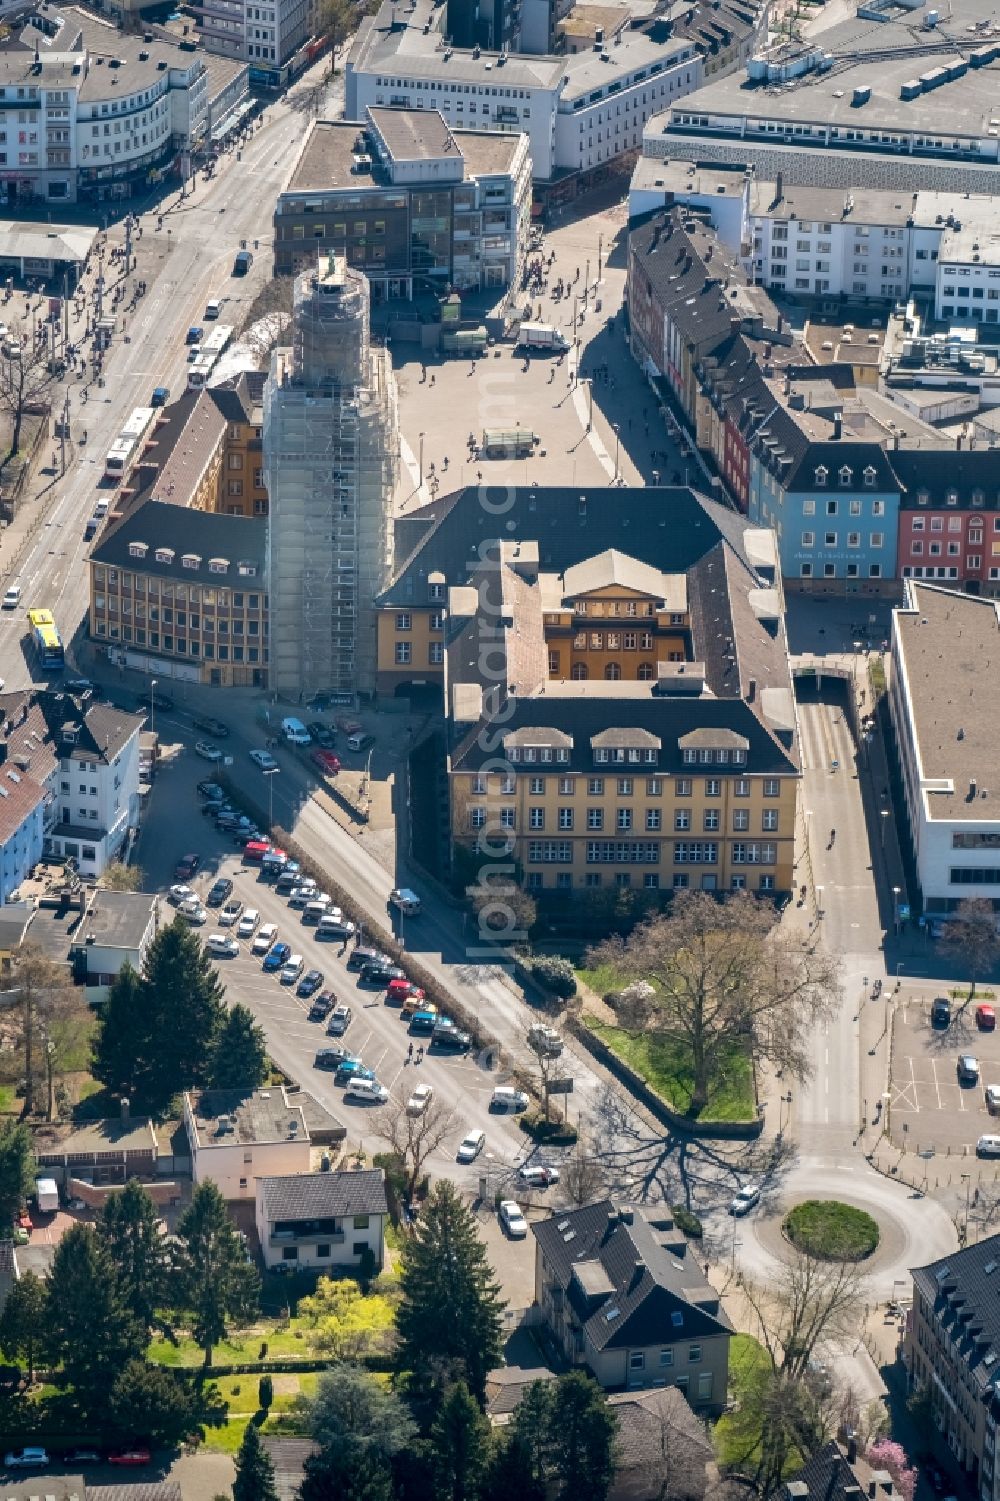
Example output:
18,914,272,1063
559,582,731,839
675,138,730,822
889,991,1000,1154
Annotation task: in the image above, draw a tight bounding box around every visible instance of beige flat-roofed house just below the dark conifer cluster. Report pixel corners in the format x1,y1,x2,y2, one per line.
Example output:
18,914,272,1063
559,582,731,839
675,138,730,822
185,1084,312,1202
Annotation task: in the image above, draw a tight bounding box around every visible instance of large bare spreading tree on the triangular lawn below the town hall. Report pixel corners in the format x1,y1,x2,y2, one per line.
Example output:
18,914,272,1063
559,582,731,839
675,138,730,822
587,892,841,1115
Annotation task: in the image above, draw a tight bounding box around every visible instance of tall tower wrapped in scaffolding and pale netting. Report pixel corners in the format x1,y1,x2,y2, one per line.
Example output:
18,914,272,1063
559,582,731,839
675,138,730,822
264,255,399,696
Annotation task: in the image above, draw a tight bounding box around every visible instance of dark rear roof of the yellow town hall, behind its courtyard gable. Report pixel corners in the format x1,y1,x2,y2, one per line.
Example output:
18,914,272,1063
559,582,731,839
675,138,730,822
377,485,759,606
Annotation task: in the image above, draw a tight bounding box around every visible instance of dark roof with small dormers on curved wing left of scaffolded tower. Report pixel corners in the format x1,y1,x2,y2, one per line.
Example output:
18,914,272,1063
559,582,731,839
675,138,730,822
90,500,267,579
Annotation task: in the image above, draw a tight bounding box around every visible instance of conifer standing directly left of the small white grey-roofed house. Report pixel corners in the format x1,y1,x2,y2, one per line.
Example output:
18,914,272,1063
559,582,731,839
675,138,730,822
177,1181,260,1366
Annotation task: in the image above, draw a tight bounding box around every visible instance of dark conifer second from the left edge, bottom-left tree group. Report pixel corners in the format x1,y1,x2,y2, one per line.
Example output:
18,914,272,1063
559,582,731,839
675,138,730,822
45,1225,149,1414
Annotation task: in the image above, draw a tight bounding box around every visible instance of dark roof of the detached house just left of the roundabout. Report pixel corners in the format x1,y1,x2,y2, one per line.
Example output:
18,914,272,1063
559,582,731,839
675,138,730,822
532,1199,731,1349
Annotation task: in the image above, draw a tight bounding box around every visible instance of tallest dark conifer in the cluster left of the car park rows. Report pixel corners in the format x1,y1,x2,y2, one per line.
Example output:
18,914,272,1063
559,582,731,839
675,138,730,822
143,917,225,1111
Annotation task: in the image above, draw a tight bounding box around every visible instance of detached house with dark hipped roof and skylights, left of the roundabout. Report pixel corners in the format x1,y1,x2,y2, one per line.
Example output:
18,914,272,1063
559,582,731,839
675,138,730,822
532,1199,733,1415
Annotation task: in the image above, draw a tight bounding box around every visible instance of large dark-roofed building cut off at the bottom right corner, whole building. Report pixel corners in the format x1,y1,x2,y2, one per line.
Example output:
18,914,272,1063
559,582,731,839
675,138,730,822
902,1235,1000,1501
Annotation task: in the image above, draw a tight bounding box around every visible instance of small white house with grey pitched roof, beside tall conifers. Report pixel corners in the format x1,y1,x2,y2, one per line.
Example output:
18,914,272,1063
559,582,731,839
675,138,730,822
257,1168,389,1271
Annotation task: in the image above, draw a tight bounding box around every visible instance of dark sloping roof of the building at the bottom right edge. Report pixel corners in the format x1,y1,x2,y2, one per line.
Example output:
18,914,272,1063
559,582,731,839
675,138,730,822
911,1235,1000,1400
